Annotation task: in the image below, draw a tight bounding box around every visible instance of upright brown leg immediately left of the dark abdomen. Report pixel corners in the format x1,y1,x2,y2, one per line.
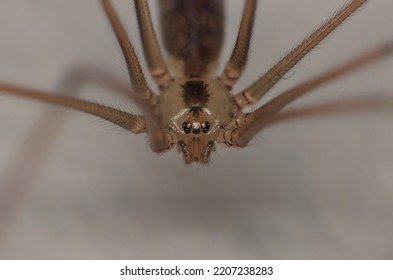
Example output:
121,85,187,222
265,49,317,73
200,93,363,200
134,0,171,87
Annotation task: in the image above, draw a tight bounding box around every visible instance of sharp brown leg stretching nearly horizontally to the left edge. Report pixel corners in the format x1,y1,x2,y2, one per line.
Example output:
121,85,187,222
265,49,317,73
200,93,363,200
0,83,146,133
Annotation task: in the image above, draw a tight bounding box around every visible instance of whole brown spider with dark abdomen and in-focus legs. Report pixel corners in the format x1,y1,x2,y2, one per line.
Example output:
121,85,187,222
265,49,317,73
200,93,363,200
0,0,393,163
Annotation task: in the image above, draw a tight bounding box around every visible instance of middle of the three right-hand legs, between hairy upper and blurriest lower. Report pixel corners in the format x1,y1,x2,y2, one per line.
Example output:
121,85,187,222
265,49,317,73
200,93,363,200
232,43,393,147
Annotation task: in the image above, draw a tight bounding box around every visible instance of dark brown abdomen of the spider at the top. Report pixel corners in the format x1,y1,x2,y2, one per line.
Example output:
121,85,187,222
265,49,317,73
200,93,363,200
159,0,224,77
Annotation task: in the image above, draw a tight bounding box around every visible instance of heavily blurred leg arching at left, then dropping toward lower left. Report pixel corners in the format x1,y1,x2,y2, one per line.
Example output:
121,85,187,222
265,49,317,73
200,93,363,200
0,67,137,246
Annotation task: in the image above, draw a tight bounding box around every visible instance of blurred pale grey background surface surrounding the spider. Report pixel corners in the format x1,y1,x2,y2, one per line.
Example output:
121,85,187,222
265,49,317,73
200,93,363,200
0,0,393,259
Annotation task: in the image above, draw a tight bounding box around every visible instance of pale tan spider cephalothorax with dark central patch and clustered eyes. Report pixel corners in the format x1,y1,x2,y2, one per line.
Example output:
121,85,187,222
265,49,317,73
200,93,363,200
156,78,237,163
